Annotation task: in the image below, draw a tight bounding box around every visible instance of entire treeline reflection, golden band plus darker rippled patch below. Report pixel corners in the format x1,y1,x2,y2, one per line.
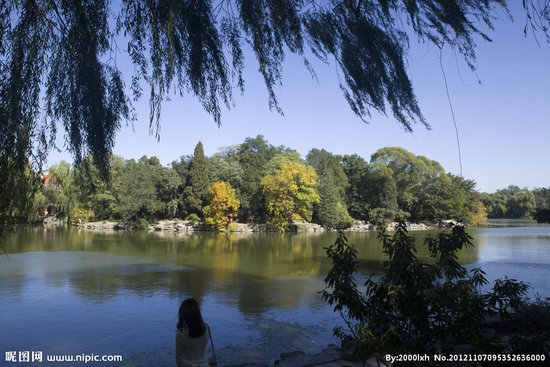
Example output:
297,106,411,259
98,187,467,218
2,227,477,314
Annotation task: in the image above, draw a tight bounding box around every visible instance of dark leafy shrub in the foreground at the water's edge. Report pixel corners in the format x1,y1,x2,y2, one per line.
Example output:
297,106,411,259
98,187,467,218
321,222,529,361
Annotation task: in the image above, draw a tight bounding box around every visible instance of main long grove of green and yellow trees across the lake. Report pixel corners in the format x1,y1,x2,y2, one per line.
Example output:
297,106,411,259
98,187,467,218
35,136,500,229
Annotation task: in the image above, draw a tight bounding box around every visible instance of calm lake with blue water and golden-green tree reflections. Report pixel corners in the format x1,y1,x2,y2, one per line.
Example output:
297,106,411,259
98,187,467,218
0,220,550,366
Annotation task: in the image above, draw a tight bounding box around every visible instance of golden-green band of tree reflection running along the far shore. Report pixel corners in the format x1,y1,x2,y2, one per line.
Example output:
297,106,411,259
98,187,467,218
1,227,484,280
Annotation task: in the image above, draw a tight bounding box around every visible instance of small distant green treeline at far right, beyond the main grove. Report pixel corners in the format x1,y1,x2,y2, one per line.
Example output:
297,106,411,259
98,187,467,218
481,185,550,222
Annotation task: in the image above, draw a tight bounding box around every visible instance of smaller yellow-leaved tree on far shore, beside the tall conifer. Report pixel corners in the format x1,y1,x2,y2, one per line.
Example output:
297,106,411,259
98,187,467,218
203,181,241,231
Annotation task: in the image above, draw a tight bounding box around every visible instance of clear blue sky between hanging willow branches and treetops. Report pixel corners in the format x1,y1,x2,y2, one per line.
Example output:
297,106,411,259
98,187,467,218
49,1,550,192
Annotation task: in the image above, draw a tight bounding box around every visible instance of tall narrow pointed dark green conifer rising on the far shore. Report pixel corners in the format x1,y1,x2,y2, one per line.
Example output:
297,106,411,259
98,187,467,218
183,141,210,216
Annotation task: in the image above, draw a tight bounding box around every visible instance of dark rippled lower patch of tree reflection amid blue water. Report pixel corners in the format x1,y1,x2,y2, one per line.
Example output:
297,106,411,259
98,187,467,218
63,264,312,314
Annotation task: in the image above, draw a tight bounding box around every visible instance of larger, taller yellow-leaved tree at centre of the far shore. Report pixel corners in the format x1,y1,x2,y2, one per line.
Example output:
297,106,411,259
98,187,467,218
261,159,319,231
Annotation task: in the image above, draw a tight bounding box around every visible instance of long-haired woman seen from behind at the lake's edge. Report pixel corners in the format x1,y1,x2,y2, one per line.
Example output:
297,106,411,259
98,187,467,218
176,298,210,367
